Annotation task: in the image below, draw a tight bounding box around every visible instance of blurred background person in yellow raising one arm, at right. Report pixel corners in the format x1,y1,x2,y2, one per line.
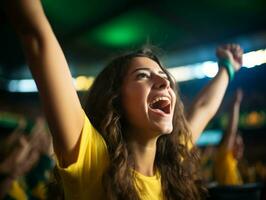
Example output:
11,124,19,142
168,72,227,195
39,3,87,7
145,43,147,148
214,89,244,185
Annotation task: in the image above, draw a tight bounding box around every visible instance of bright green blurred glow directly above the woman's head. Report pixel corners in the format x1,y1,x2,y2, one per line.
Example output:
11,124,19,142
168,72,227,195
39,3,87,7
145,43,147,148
84,10,184,48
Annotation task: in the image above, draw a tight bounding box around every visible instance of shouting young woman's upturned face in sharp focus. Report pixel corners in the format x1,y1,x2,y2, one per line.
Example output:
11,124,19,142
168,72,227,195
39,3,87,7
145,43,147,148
122,57,176,136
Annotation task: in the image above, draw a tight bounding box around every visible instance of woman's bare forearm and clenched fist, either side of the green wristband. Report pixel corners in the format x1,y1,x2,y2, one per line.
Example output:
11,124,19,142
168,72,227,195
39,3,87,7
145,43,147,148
187,44,243,143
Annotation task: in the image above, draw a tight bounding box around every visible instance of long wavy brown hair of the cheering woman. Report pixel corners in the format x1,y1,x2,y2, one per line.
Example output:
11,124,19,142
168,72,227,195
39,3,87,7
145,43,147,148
84,48,205,200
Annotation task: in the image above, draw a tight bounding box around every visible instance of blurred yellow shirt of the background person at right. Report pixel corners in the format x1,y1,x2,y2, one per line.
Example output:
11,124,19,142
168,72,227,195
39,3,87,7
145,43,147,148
214,146,243,185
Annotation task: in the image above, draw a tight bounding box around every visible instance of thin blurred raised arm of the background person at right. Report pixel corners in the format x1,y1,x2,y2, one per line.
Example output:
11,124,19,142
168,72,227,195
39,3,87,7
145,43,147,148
222,89,243,150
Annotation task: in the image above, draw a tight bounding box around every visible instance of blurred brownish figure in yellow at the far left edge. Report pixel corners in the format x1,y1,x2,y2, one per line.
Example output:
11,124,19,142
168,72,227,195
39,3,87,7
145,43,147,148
0,118,38,200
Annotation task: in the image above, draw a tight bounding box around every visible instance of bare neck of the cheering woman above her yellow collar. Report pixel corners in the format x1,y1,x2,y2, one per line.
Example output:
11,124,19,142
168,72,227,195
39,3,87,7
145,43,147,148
128,133,157,176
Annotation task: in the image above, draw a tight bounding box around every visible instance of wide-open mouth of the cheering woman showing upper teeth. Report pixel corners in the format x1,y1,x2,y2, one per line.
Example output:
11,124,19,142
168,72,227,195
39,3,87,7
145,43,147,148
149,97,171,114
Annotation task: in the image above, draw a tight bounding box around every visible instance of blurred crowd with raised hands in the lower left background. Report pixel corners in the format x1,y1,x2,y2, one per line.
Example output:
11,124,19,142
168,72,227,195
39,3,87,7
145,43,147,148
0,113,54,200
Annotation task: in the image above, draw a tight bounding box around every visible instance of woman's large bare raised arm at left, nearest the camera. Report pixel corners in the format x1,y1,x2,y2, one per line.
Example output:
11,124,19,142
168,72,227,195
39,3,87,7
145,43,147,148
4,0,83,165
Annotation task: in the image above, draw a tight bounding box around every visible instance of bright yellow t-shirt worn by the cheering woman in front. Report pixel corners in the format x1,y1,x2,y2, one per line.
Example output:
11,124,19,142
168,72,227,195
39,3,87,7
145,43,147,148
58,111,162,200
